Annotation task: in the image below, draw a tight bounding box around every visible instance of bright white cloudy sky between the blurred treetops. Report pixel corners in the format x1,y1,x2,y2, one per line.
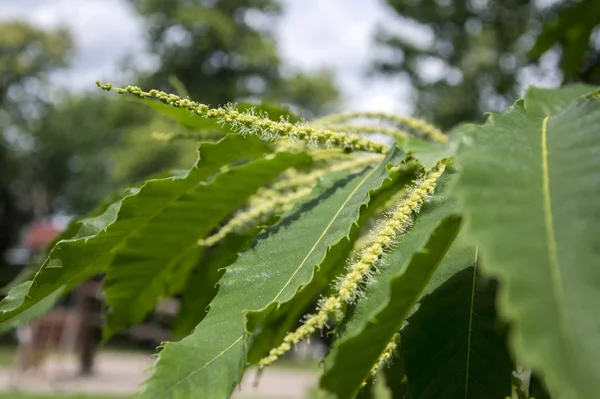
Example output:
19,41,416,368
0,0,411,112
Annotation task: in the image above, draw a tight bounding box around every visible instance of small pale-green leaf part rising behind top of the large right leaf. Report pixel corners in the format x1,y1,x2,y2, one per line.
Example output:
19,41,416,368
525,84,599,118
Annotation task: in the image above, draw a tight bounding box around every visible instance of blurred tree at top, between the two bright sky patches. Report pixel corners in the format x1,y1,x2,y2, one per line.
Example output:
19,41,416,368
131,0,279,105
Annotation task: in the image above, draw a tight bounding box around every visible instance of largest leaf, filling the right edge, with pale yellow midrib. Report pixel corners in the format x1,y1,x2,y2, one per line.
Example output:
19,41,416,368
456,98,600,399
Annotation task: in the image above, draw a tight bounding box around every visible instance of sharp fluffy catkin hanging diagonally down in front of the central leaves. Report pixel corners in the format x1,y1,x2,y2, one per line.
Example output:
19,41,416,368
259,163,445,368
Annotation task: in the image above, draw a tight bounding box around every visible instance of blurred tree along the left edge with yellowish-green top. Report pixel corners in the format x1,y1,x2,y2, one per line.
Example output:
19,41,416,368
0,21,72,268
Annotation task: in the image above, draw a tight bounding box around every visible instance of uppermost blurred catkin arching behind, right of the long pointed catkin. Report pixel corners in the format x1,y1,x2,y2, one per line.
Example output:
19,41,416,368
313,112,448,143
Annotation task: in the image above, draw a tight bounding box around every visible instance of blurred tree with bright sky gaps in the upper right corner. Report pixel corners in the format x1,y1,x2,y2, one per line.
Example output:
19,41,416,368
375,0,600,128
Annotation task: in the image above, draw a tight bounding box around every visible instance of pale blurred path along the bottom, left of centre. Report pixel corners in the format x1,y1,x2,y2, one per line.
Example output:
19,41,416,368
0,352,317,399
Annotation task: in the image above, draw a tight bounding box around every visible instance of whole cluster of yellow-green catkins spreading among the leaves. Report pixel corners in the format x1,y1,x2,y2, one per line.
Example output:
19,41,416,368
98,83,446,382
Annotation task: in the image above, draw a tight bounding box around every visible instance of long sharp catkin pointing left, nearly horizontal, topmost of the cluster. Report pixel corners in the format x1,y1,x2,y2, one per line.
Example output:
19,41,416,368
97,82,389,153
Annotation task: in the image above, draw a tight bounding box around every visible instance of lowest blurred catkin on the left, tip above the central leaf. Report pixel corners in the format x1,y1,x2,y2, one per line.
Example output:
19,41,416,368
198,187,312,246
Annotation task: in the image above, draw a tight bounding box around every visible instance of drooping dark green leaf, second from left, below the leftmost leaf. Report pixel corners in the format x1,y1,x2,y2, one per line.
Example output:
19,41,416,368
104,145,309,337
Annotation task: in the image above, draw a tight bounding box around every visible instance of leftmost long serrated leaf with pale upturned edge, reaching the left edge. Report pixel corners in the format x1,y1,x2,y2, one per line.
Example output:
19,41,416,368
0,135,268,323
